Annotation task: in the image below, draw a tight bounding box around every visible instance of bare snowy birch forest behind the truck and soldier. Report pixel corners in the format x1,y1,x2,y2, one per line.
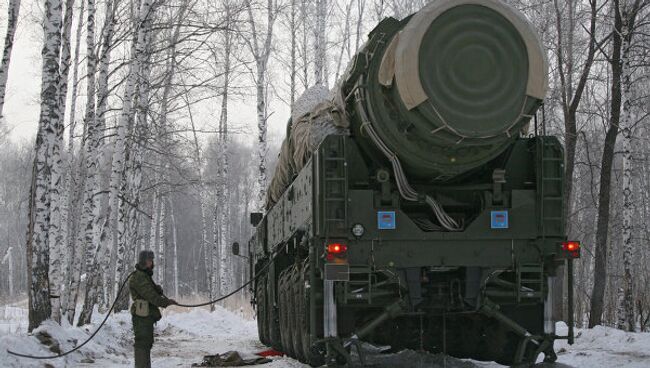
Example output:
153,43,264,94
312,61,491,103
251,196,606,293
0,0,650,331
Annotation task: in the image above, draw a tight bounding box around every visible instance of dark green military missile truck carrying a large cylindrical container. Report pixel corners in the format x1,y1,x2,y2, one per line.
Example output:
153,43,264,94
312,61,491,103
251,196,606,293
239,0,580,366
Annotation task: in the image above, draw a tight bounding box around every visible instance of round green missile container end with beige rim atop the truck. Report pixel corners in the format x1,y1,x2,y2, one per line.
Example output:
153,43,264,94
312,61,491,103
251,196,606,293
341,0,548,182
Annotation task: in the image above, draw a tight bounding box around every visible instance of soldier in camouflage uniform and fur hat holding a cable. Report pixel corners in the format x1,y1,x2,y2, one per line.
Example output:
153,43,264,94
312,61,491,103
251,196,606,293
129,250,176,368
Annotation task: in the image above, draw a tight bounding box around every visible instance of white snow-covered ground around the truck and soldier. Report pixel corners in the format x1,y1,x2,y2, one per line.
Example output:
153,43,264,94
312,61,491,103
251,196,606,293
0,303,650,368
